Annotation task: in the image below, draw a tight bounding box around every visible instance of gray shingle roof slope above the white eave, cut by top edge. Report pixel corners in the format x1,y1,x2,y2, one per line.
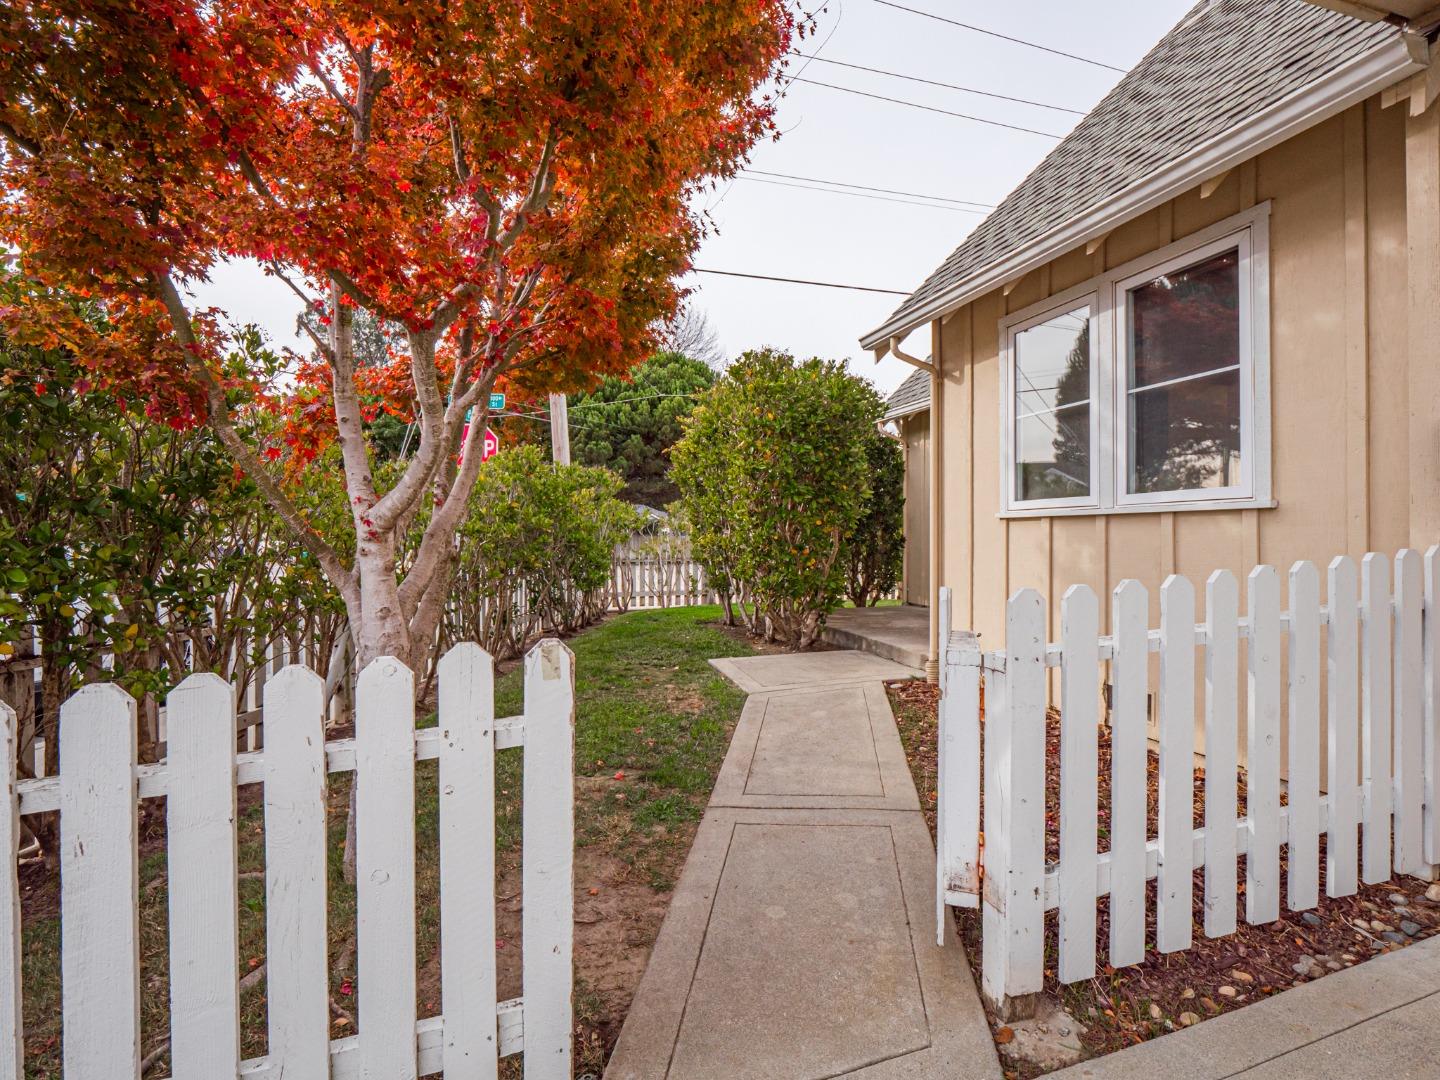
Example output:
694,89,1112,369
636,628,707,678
858,0,1400,347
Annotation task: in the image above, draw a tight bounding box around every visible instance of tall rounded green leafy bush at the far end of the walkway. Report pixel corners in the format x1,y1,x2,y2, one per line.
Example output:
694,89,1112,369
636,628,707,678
671,348,883,648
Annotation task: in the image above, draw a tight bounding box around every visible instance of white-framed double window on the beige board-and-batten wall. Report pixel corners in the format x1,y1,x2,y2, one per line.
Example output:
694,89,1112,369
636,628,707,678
1001,203,1272,516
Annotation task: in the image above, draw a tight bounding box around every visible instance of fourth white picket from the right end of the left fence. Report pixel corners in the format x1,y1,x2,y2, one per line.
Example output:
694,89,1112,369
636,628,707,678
265,667,330,1080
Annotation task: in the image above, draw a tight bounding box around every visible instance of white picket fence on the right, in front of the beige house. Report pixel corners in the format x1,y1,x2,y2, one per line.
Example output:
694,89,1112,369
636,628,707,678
936,546,1440,1008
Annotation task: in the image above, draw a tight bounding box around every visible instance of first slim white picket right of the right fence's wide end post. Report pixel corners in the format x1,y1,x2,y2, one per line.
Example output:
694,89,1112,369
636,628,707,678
1058,585,1100,982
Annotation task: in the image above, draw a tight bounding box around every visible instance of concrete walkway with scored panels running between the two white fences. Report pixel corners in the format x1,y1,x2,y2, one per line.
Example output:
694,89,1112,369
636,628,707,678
605,652,1001,1080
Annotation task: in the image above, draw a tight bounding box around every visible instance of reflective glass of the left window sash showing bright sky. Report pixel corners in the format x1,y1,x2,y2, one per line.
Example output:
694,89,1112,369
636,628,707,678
1014,307,1090,500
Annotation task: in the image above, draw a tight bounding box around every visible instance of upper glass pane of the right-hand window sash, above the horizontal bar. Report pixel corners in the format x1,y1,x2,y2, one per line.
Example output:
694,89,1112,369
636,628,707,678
1129,251,1240,387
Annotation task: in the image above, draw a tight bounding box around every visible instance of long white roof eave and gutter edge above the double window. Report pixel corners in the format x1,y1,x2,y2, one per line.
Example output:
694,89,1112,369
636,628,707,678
860,33,1430,356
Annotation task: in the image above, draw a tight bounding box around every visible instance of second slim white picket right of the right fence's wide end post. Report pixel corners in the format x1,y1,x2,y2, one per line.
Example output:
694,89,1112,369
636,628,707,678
1100,580,1149,968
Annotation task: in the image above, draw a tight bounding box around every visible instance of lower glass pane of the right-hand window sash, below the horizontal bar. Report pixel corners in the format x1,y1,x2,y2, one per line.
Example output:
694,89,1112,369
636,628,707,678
1130,369,1243,494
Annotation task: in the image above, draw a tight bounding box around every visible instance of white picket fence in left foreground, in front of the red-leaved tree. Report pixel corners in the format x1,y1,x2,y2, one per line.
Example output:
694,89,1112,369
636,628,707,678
0,639,575,1080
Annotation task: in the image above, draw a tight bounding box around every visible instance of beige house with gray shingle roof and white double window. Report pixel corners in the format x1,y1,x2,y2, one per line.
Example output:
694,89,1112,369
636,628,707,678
863,0,1440,676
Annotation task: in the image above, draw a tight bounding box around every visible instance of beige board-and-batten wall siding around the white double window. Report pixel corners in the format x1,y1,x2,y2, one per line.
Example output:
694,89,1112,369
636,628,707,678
937,96,1440,760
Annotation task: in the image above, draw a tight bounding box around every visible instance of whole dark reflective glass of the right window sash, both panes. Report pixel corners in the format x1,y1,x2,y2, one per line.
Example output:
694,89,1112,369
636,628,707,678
1126,251,1243,494
